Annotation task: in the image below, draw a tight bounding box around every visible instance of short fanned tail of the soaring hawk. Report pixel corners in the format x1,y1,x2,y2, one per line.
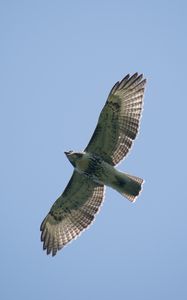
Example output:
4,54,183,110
112,172,144,202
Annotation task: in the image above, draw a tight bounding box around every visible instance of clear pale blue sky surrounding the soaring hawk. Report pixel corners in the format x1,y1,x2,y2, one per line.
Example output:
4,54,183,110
0,0,187,300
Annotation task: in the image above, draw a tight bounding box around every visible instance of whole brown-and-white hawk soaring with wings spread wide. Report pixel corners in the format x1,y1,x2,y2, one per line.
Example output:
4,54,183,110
40,73,146,256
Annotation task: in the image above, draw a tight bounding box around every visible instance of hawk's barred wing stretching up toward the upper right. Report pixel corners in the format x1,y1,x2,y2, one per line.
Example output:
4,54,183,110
85,73,146,165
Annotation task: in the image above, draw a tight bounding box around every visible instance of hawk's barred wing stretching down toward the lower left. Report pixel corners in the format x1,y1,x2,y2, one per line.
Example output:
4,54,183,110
40,171,104,256
